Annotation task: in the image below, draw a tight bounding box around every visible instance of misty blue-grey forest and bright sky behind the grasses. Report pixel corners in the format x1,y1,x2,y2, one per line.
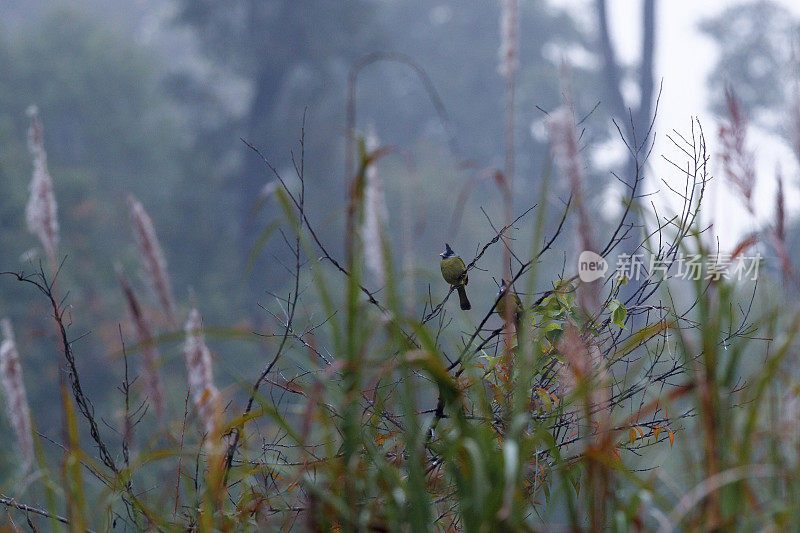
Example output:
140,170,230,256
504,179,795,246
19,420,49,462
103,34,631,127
0,0,800,476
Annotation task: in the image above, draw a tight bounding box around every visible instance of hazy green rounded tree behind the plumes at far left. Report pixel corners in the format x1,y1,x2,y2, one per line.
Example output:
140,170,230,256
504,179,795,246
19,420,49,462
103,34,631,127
0,7,190,432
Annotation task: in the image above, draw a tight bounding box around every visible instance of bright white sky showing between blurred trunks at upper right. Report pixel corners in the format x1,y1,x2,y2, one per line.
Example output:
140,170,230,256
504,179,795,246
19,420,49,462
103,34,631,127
550,0,800,248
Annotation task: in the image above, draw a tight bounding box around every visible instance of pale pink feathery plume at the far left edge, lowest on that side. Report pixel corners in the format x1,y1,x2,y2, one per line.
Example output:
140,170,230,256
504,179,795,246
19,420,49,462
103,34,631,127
0,318,34,470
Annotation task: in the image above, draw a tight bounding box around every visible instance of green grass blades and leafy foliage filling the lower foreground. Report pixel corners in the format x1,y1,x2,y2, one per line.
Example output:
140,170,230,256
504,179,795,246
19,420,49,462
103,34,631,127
6,119,800,531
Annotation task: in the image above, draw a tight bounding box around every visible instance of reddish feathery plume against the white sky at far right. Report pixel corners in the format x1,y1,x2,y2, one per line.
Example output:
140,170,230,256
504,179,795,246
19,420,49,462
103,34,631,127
719,87,756,215
